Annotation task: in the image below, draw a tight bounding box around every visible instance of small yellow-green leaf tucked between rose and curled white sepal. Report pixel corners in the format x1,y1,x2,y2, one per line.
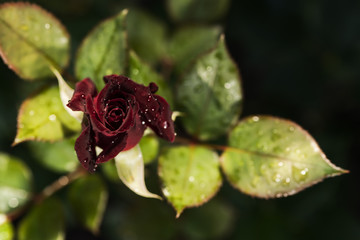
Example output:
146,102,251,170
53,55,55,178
139,135,160,164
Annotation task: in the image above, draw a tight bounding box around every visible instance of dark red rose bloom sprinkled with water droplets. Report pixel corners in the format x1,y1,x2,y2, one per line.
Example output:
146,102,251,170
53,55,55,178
67,75,175,172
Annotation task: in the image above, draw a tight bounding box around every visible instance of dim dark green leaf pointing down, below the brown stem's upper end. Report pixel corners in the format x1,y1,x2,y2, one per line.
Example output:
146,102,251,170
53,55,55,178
68,175,108,233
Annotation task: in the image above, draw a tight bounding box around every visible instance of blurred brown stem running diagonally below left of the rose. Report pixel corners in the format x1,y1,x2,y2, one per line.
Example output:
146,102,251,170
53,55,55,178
6,166,87,221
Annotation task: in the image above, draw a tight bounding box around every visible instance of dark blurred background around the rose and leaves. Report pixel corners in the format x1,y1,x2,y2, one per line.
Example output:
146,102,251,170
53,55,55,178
0,0,360,240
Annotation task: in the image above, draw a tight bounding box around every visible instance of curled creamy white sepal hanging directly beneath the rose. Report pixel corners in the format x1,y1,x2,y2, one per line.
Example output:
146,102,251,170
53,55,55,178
115,145,161,199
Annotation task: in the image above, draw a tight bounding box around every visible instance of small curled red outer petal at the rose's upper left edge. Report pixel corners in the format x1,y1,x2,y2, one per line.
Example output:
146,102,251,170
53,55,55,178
67,78,97,112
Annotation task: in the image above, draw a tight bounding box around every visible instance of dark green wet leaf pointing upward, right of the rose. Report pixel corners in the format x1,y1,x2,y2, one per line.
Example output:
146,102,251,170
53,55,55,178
177,38,242,140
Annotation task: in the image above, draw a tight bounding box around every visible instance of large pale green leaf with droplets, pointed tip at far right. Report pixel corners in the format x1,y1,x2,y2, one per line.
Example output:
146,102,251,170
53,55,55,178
221,116,346,198
